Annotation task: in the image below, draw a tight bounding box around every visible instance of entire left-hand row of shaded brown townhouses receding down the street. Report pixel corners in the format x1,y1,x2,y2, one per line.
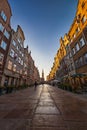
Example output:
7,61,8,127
0,0,40,86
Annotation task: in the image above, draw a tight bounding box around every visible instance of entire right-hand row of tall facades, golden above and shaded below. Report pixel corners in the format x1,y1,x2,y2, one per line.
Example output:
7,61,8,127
47,0,87,80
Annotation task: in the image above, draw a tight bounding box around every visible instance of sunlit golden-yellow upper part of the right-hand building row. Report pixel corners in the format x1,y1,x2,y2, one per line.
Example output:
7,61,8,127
47,0,87,80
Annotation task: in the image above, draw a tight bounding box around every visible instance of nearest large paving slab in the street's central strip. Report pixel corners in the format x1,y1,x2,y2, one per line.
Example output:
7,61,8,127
33,114,66,127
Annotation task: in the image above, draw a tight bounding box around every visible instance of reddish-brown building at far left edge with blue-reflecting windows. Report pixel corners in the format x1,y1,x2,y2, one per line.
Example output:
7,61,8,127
0,0,12,85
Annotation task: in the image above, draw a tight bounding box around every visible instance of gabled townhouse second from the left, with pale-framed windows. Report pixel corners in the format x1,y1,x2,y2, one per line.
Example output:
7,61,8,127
2,25,25,86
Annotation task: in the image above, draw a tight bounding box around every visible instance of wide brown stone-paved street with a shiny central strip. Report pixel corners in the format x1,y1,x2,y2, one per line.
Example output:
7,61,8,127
0,85,87,130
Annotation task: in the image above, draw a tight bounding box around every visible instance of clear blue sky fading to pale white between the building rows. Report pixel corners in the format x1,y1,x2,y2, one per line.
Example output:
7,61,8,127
8,0,77,78
